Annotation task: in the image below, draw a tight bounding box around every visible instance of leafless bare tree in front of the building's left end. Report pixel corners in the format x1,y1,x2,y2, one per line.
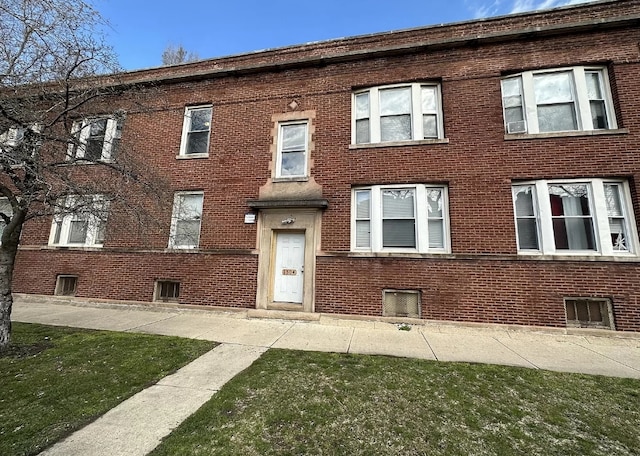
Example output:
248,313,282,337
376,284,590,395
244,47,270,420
0,0,169,350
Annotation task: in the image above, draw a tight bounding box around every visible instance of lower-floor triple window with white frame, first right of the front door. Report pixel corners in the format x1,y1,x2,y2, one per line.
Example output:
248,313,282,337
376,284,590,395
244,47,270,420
351,185,449,253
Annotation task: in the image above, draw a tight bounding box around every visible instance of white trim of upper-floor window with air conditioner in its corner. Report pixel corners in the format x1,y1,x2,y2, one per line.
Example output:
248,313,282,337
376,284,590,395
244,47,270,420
502,66,618,135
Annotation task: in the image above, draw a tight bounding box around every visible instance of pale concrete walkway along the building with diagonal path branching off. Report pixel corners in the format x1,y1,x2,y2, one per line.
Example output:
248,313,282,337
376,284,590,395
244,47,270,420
12,296,640,456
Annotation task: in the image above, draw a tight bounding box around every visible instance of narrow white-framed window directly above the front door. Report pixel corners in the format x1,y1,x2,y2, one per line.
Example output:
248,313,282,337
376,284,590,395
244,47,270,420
276,121,309,177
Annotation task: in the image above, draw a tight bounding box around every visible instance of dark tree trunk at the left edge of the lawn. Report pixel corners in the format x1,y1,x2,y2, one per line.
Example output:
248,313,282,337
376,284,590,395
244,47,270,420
0,213,24,351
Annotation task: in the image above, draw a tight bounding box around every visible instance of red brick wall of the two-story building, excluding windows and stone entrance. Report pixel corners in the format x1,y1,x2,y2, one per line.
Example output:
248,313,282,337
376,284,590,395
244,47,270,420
14,0,640,331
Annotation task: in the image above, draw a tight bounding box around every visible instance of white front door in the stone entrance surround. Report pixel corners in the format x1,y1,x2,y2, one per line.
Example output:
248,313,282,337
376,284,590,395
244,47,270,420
273,231,304,304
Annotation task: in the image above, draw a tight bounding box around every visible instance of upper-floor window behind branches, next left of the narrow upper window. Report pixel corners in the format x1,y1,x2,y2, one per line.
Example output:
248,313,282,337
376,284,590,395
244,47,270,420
67,117,123,162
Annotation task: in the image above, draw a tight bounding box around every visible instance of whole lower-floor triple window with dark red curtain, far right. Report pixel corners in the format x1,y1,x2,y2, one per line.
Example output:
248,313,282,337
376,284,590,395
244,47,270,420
512,179,638,255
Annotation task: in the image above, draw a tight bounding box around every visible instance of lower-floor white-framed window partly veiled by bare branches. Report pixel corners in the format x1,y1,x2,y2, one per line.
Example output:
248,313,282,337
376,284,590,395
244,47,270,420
49,195,108,247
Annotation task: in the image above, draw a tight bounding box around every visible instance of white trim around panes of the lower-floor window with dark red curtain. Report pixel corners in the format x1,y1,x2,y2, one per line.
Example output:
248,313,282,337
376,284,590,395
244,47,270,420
511,178,640,257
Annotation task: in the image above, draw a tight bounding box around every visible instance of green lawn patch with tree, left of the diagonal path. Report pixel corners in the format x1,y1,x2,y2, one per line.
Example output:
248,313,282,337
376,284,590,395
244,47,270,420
0,323,214,456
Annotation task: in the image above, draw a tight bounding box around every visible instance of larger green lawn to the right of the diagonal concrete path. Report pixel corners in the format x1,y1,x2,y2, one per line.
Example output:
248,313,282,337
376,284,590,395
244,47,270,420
152,349,640,456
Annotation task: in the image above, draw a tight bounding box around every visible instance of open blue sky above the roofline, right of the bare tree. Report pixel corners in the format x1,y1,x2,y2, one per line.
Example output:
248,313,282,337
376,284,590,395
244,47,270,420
95,0,589,70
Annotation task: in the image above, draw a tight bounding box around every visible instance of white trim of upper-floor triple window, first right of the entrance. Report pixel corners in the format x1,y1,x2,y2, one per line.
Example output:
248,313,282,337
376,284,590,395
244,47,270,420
351,82,444,146
